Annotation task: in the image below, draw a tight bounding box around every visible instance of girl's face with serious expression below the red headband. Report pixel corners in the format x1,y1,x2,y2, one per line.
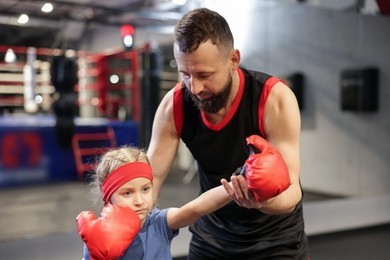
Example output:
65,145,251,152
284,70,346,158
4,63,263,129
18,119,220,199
110,177,154,225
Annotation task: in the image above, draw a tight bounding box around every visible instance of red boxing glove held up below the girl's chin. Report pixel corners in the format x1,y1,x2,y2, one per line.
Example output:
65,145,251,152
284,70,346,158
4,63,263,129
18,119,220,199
76,204,141,260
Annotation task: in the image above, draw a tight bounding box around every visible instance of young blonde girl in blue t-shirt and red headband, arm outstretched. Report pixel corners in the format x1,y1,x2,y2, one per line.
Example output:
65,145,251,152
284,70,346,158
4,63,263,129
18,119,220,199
76,146,231,260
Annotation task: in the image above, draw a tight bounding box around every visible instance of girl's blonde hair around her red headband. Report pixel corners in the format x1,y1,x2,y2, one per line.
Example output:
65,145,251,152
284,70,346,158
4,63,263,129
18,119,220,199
91,146,149,202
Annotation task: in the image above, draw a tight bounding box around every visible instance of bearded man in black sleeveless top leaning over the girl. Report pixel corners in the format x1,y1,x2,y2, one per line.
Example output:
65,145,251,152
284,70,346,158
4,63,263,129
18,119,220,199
148,8,309,260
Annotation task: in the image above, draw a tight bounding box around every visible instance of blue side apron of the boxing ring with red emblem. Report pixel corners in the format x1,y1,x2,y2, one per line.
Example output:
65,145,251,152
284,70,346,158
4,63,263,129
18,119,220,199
0,115,138,188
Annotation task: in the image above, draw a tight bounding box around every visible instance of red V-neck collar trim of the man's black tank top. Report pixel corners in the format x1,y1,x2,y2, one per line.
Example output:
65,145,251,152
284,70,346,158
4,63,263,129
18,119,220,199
201,68,245,131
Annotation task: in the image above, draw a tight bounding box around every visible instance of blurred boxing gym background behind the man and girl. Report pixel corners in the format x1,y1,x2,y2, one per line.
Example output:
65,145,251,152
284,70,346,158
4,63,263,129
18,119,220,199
0,0,390,260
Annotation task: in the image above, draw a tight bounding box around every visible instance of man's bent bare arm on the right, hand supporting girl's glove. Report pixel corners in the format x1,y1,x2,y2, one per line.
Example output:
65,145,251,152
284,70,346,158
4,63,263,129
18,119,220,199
222,82,302,214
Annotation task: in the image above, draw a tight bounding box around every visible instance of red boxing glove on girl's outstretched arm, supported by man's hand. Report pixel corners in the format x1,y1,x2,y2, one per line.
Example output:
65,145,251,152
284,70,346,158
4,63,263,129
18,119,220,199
245,135,291,201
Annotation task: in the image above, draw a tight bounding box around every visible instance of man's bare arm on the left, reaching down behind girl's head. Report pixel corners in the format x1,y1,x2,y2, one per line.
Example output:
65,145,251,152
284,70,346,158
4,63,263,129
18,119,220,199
147,89,180,197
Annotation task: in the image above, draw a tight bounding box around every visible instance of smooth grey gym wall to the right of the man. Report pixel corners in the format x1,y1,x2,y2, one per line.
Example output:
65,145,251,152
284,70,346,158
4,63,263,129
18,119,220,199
208,0,390,195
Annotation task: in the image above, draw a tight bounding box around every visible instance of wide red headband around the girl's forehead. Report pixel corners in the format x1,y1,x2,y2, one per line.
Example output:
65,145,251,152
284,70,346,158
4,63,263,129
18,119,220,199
102,162,153,204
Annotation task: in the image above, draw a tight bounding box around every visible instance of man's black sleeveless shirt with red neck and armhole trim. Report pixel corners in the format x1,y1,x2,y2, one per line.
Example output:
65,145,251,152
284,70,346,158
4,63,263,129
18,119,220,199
174,69,307,259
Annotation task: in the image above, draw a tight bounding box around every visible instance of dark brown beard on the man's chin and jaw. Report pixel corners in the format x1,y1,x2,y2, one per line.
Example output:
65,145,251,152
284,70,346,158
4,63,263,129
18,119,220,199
190,74,233,114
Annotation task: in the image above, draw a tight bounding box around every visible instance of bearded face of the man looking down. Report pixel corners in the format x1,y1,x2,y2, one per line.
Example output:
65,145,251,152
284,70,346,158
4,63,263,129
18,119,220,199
174,41,232,113
